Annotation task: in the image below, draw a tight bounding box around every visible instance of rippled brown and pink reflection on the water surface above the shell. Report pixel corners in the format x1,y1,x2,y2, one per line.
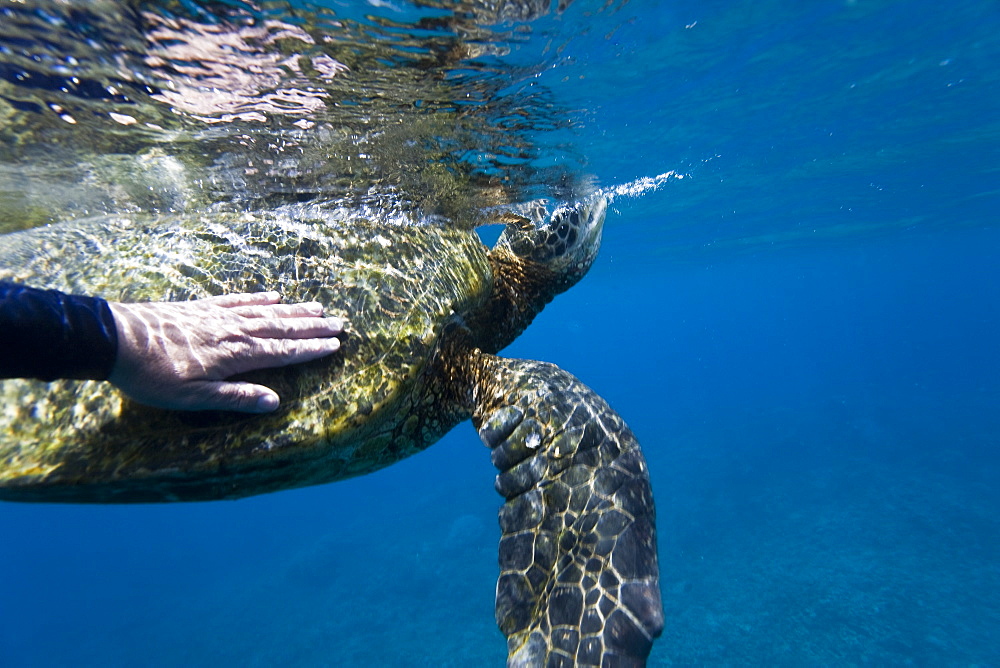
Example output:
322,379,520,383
0,0,584,230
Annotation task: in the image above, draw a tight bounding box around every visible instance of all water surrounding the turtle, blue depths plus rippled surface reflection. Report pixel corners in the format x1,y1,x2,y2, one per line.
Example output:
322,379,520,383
0,0,1000,668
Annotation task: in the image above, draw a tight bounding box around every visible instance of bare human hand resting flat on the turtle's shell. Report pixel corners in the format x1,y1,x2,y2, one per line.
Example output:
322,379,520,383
108,292,344,413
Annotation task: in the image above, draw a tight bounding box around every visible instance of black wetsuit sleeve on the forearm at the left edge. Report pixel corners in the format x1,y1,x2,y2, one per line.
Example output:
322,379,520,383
0,281,118,380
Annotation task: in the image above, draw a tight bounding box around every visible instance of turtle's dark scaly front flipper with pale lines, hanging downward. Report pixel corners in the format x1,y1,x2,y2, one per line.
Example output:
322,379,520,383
473,354,663,666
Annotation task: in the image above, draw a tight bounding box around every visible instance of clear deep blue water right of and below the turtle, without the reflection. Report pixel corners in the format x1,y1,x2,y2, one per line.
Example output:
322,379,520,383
0,0,1000,666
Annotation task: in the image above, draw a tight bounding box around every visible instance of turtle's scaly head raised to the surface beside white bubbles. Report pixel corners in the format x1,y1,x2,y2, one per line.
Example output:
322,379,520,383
496,195,608,294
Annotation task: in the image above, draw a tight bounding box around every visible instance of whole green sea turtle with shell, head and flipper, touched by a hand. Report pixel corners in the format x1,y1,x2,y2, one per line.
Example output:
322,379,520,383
0,201,663,666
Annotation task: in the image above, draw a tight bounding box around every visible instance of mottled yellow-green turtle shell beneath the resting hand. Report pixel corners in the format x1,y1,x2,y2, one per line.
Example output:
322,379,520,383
0,212,493,503
